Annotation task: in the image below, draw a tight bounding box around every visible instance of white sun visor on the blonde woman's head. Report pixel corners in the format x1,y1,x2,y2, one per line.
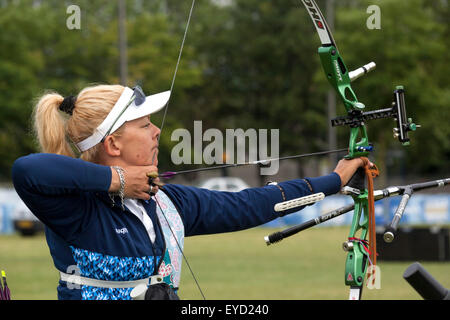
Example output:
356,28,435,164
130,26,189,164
76,87,170,152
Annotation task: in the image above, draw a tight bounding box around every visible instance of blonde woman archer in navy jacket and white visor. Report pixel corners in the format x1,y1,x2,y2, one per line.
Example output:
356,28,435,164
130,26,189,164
12,85,363,299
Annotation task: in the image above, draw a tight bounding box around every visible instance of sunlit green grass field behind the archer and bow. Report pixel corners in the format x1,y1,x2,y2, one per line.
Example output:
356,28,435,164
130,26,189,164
0,227,450,300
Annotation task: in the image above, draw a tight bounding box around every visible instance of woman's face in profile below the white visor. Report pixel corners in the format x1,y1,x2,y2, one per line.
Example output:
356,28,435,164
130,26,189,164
117,116,161,166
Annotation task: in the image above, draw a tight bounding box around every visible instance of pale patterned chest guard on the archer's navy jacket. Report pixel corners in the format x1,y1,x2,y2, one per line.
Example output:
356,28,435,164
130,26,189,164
155,192,184,288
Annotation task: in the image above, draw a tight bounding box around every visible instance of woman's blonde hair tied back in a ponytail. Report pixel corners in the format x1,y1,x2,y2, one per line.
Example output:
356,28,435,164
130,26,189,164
33,85,125,162
